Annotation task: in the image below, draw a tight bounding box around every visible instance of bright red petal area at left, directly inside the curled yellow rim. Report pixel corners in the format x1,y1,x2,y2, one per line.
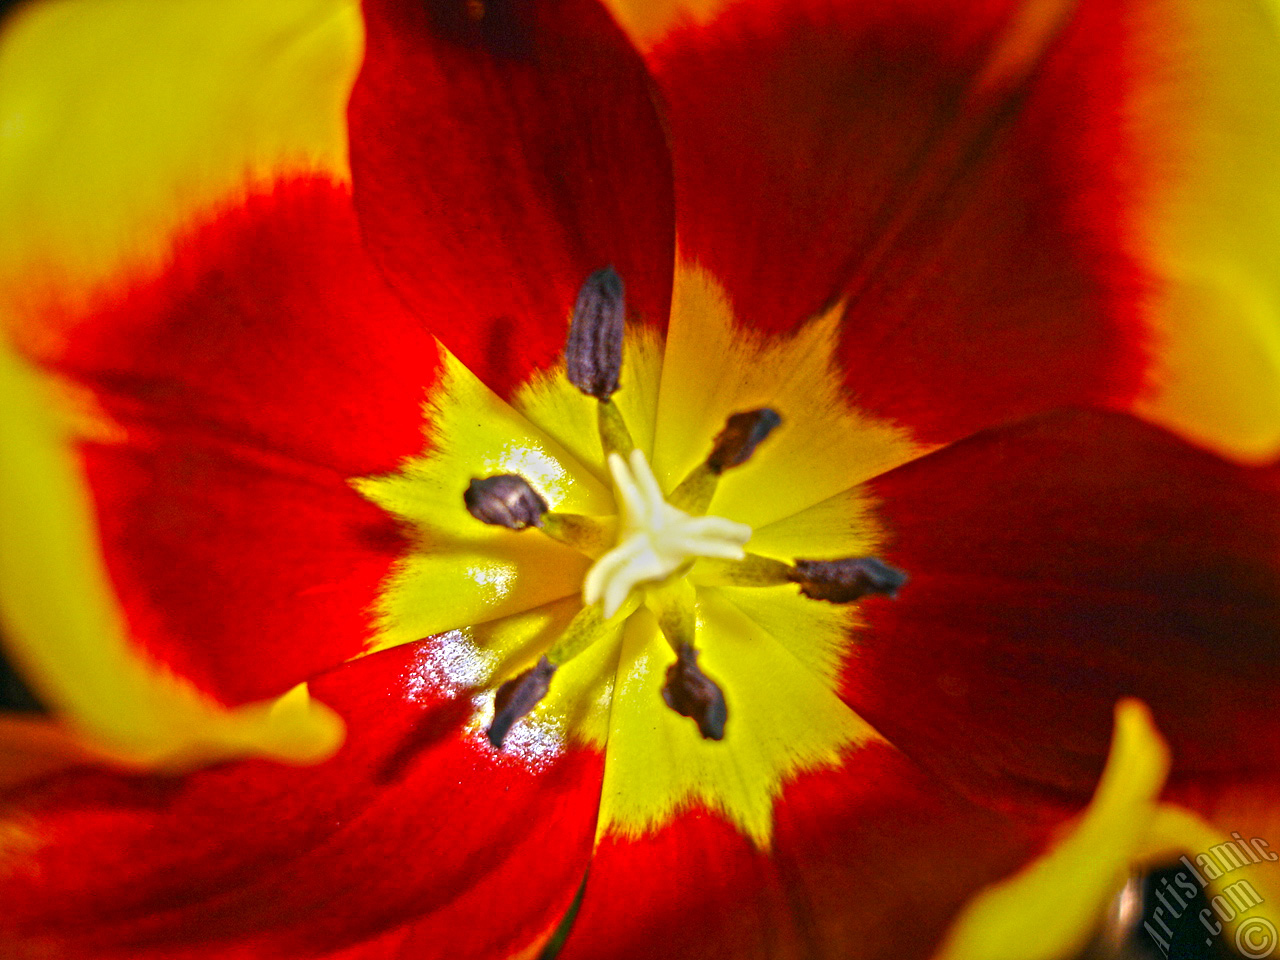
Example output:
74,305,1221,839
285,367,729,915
77,437,404,703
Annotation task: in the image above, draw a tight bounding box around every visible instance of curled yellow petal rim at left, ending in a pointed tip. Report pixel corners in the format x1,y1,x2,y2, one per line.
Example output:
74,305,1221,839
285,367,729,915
0,340,343,772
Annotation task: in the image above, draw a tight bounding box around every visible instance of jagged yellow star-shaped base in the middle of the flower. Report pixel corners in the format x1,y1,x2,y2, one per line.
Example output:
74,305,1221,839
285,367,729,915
355,265,919,846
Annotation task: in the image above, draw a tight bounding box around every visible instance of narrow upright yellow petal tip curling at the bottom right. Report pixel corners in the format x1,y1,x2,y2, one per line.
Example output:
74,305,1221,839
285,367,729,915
937,700,1169,960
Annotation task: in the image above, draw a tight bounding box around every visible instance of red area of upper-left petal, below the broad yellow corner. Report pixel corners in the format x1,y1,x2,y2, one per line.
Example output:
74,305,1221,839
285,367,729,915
46,179,440,477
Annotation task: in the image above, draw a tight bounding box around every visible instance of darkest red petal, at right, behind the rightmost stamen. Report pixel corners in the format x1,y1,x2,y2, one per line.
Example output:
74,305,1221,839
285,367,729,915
846,412,1280,819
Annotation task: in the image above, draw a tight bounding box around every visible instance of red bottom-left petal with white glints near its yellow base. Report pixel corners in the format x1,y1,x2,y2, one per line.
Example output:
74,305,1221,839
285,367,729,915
0,645,602,960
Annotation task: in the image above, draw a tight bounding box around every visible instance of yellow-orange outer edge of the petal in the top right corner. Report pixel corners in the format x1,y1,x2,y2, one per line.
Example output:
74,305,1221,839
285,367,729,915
1130,0,1280,460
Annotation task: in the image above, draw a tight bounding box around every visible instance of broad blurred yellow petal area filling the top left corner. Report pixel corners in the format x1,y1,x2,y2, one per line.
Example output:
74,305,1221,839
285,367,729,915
0,0,364,316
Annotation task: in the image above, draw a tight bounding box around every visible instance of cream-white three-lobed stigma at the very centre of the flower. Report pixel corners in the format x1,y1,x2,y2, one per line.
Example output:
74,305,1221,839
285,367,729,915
582,449,751,618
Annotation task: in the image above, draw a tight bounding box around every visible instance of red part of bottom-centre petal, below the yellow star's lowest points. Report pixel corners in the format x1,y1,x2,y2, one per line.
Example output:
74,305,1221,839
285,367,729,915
561,745,1028,960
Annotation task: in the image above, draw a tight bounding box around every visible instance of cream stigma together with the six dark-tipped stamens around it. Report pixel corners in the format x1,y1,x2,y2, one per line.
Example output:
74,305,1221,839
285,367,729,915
463,268,906,748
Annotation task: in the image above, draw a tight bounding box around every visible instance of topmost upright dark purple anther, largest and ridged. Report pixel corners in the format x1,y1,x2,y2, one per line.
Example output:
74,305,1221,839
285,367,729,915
564,266,626,401
